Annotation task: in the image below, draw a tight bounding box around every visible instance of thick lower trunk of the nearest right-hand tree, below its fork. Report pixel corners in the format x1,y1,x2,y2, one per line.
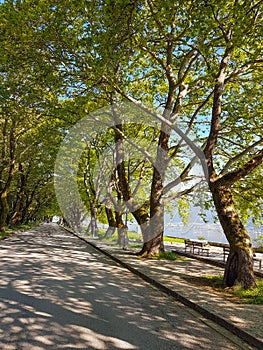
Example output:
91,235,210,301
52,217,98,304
210,180,256,289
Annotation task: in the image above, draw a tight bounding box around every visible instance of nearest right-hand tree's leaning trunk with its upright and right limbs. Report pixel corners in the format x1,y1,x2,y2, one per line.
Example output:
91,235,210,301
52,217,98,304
204,42,260,289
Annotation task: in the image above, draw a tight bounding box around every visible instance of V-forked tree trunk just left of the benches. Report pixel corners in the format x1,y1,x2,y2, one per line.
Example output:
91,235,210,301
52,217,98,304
113,104,169,258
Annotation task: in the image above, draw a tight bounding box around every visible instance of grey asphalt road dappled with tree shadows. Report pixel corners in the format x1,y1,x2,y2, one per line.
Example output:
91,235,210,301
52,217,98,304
0,224,253,350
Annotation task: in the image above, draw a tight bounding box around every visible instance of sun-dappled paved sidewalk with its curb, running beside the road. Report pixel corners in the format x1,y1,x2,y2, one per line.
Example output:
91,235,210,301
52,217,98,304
75,236,263,349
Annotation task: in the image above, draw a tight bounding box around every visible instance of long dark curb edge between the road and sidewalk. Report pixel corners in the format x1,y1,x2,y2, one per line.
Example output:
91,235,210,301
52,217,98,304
63,227,263,350
